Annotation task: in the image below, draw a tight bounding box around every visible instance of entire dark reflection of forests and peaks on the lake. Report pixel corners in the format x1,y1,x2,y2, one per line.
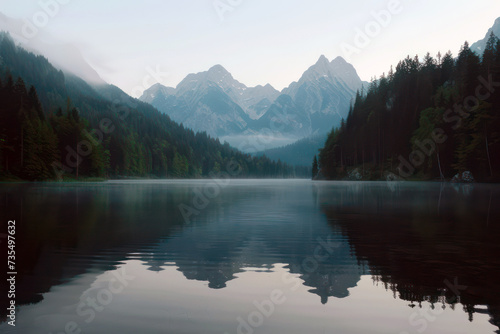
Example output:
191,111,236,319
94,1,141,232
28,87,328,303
0,183,500,330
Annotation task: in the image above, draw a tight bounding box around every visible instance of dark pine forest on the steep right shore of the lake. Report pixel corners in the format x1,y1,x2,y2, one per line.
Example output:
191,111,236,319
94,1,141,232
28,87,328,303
319,33,500,182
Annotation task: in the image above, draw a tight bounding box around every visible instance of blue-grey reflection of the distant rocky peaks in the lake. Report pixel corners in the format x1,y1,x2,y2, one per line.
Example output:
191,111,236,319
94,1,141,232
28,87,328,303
140,190,363,303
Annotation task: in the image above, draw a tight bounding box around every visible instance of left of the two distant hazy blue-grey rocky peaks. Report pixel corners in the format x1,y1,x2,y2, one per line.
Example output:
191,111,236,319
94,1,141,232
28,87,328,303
141,65,279,136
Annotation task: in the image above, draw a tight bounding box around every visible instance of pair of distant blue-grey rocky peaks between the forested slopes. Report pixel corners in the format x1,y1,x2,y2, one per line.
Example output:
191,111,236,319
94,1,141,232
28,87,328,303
140,56,363,151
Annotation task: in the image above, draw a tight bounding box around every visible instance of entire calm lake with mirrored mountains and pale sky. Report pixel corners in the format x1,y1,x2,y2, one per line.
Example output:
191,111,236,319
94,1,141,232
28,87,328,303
0,180,500,334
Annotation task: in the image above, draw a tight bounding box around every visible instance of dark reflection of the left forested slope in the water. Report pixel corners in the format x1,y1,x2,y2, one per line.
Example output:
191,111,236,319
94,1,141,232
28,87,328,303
0,184,191,321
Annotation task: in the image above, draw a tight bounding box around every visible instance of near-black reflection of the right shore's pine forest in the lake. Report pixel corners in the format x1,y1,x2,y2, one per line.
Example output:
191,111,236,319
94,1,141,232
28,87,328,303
316,183,500,332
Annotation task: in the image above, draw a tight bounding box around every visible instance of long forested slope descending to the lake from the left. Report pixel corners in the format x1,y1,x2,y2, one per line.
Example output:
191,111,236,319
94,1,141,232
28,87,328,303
0,33,308,181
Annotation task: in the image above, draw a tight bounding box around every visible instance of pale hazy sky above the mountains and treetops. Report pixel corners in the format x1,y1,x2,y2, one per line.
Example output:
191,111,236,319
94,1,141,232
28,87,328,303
0,0,500,95
